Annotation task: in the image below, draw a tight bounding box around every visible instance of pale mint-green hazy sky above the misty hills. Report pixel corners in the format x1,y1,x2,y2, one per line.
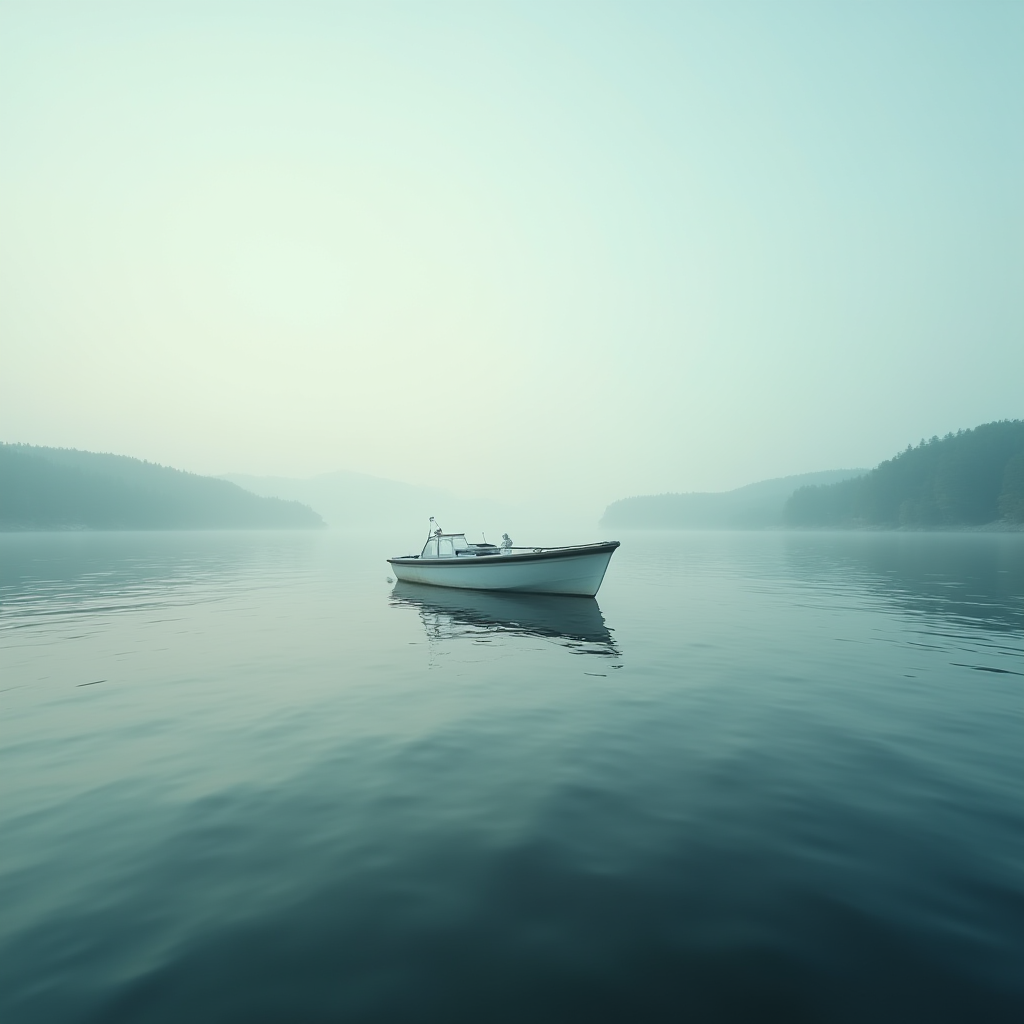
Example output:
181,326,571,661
0,0,1024,501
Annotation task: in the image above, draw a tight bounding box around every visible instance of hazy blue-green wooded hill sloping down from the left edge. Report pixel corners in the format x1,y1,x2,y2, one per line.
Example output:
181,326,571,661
0,444,324,529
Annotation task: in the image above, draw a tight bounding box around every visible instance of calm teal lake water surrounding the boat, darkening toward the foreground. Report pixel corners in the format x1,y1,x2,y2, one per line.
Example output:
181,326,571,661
0,534,1024,1024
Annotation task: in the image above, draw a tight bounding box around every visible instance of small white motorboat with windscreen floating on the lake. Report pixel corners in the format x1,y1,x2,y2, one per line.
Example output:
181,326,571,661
388,516,618,597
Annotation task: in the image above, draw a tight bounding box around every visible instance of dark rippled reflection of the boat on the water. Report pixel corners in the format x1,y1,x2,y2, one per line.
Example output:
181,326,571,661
390,583,621,657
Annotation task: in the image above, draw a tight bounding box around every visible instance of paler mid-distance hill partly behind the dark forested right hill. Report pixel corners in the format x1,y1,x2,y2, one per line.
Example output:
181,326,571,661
601,469,867,529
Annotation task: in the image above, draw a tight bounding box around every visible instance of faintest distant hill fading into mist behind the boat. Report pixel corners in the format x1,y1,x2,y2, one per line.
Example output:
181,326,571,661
220,470,519,537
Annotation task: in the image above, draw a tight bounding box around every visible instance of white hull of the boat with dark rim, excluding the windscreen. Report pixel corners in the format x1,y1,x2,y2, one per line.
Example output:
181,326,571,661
388,541,618,597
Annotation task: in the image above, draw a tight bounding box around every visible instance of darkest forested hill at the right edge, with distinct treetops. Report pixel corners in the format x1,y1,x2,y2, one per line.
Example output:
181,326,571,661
785,420,1024,528
